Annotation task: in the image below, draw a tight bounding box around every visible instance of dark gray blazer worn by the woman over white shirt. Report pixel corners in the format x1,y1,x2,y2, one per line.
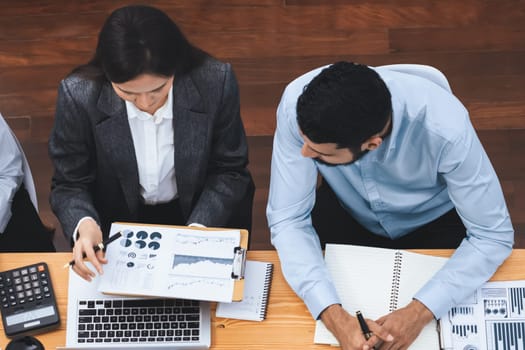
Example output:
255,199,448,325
49,58,254,243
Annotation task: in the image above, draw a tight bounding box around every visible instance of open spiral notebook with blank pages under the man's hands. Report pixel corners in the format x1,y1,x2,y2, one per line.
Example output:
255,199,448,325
314,244,447,350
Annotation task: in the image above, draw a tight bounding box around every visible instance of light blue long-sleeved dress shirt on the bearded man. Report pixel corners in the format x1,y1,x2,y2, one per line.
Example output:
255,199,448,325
267,67,514,318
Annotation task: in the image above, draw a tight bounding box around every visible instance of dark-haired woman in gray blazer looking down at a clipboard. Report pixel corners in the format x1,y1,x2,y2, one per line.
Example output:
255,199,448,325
49,6,254,280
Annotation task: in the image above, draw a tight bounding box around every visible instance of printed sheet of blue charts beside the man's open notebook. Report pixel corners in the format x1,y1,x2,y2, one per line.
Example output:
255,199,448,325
440,280,525,350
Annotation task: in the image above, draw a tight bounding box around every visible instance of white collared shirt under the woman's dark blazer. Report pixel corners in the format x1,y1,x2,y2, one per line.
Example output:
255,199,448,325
126,87,177,205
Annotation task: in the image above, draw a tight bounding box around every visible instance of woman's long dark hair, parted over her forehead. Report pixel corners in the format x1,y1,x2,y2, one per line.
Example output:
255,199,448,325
73,5,208,83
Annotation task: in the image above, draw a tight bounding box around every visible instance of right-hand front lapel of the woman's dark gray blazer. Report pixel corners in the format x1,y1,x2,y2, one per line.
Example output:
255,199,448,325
173,74,209,218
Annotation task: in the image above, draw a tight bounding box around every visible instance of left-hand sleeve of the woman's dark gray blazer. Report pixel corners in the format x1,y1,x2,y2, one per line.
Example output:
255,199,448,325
48,80,99,242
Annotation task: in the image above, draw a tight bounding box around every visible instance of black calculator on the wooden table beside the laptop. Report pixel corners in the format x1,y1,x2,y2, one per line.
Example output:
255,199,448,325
0,262,60,337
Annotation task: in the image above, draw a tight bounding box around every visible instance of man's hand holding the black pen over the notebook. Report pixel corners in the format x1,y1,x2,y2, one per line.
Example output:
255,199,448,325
321,304,394,350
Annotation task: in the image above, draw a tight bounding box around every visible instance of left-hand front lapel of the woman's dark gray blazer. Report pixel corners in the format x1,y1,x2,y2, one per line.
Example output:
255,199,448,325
96,84,139,215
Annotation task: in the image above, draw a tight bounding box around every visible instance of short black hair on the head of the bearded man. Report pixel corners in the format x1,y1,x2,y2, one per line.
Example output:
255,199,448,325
297,62,392,148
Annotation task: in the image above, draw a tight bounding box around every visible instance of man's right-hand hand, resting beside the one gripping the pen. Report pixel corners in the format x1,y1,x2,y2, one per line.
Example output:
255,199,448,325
376,299,434,350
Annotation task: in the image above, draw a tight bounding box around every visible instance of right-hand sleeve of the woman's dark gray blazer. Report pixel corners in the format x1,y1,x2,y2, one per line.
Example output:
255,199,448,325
188,64,254,229
